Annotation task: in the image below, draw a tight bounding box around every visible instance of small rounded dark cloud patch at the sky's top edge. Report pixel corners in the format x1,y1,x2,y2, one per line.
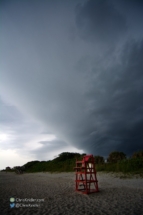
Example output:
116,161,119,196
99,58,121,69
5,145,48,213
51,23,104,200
76,0,127,43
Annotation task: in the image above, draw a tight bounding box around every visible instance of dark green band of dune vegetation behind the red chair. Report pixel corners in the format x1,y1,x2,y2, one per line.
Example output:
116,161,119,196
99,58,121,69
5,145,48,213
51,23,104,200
3,151,143,176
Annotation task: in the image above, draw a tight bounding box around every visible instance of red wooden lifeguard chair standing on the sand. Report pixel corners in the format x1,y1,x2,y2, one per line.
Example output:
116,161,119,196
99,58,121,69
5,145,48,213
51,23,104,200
74,155,99,194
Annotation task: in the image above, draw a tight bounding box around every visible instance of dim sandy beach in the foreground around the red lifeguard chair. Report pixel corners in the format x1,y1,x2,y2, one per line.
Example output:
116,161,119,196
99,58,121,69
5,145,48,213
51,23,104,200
0,172,143,215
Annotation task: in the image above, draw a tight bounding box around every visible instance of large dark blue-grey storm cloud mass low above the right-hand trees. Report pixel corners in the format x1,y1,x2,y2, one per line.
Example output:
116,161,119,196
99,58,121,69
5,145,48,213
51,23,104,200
81,39,143,154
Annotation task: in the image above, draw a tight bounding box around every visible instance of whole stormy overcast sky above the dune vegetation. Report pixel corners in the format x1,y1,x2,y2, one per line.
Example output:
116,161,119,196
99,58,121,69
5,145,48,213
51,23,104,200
0,0,143,169
